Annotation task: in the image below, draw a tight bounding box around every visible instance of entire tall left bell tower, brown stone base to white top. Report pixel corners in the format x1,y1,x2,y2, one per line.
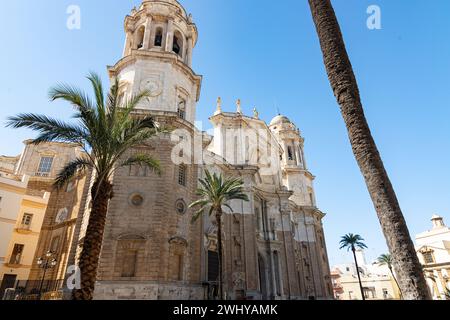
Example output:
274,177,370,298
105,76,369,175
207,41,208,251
94,0,204,300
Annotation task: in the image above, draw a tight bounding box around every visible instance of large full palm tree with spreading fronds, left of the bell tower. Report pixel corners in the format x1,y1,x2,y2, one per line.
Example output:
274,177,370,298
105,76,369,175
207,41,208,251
7,73,160,300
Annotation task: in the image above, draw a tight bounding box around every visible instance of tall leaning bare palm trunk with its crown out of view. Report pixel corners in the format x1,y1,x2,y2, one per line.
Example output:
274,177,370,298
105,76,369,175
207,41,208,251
308,0,430,300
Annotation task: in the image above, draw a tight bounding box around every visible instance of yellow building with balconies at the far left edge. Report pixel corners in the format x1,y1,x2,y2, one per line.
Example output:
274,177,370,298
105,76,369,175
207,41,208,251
0,172,50,297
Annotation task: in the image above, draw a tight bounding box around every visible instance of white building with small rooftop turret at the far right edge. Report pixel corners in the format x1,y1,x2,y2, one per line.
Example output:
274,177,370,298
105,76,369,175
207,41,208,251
416,215,450,300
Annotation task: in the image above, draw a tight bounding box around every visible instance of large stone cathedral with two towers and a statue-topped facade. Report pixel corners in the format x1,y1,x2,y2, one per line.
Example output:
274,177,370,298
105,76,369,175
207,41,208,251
1,0,333,300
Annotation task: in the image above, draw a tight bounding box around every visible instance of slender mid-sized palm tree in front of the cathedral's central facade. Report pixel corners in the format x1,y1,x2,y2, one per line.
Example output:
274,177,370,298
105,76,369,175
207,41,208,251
189,170,249,300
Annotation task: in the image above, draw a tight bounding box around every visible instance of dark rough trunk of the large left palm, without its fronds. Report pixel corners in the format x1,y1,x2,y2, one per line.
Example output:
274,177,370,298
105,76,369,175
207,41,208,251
73,180,112,300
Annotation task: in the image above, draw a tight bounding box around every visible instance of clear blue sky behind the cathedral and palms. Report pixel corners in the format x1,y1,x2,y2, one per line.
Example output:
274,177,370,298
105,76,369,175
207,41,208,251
0,0,450,264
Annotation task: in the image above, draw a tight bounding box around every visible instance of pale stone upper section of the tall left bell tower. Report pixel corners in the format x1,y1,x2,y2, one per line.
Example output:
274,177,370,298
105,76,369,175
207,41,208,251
108,0,202,124
